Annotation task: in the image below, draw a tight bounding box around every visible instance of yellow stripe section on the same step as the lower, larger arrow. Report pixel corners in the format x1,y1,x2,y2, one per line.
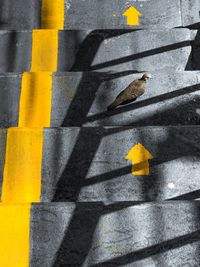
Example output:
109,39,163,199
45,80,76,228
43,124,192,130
1,128,43,203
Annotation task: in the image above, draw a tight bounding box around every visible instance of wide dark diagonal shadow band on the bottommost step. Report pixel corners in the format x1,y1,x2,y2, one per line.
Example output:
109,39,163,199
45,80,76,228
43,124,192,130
52,203,103,267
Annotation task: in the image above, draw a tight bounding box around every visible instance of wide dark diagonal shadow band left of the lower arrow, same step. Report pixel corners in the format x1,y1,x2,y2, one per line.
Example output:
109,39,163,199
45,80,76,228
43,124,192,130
53,128,103,202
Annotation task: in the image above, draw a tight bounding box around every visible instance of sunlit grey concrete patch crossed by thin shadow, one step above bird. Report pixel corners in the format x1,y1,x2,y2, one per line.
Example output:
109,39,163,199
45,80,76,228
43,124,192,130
86,29,191,71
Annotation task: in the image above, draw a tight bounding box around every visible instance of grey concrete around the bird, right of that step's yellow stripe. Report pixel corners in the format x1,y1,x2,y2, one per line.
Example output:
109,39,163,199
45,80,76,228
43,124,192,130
51,71,200,126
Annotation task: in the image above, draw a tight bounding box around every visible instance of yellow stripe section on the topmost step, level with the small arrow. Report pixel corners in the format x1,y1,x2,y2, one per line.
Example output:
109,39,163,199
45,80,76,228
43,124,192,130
41,0,65,30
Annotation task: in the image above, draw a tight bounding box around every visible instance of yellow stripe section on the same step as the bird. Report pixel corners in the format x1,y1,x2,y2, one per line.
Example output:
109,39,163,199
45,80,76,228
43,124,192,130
18,72,52,127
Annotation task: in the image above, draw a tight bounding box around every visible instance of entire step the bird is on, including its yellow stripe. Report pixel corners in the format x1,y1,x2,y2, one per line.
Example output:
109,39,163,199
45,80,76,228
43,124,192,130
0,71,200,127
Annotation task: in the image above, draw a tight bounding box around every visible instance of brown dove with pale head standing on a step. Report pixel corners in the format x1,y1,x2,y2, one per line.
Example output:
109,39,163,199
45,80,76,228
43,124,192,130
107,73,152,111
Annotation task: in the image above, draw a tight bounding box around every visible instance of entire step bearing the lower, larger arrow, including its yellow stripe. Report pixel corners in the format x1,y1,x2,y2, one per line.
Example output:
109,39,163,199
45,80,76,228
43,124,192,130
0,127,200,203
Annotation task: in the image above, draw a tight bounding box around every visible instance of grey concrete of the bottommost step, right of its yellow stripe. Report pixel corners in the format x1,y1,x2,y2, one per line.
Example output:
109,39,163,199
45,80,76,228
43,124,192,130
30,201,200,267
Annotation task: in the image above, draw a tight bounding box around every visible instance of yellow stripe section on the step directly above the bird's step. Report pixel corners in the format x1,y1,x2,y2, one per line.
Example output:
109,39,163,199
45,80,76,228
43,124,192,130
31,30,59,72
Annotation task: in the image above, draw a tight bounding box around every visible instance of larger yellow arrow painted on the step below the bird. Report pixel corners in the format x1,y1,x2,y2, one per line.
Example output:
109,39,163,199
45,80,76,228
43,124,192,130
125,144,153,176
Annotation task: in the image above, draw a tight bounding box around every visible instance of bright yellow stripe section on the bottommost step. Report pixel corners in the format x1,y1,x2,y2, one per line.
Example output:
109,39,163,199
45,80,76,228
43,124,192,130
0,204,31,267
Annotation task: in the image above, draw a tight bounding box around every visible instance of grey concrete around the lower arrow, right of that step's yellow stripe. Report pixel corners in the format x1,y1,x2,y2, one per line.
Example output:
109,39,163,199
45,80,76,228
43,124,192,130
1,127,200,203
